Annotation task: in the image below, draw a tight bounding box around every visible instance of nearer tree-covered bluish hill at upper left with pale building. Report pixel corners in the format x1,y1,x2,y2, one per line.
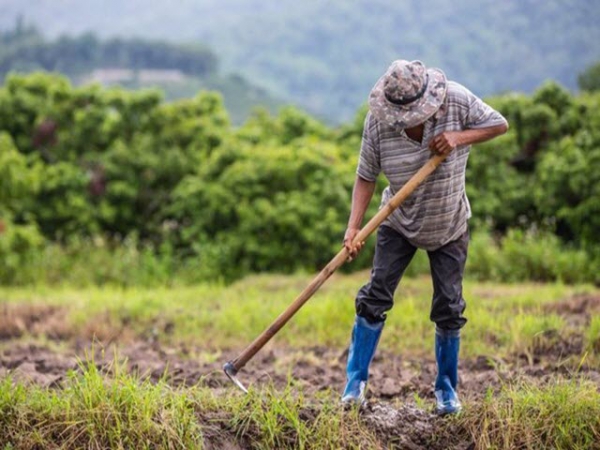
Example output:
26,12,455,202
0,20,281,124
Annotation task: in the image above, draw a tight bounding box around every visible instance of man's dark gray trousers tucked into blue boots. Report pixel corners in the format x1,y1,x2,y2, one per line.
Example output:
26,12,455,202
356,225,469,330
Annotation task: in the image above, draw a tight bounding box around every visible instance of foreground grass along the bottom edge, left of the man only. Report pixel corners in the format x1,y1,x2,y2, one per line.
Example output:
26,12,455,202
0,361,378,449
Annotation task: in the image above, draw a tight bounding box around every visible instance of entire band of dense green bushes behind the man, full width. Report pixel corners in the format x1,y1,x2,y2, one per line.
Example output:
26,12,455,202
0,74,600,286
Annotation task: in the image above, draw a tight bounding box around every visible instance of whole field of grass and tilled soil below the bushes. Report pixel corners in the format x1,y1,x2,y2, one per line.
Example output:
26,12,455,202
0,272,600,449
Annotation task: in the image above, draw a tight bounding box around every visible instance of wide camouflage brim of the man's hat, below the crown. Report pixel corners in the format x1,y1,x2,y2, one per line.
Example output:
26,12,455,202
369,68,448,128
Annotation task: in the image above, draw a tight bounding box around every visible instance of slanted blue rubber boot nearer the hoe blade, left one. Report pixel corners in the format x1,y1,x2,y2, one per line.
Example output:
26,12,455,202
342,316,383,404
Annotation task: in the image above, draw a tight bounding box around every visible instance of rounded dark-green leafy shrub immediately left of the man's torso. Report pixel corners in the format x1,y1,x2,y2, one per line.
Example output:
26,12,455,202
171,140,353,276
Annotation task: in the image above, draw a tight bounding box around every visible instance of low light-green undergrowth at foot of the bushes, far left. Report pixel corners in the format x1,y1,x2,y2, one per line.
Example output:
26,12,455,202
0,234,220,286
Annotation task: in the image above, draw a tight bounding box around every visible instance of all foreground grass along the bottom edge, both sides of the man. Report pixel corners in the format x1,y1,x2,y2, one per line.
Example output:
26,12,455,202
0,362,600,450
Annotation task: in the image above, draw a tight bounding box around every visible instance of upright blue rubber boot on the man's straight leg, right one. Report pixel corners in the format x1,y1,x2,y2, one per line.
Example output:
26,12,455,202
435,329,462,415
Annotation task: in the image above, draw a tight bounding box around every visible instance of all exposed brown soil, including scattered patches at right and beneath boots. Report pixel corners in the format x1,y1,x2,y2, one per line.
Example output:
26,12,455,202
0,296,600,450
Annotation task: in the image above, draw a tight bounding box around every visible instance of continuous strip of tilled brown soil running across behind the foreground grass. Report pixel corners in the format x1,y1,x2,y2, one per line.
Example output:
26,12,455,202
0,342,600,403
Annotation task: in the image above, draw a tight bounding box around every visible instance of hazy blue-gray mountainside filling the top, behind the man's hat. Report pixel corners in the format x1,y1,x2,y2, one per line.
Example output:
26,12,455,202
0,0,600,121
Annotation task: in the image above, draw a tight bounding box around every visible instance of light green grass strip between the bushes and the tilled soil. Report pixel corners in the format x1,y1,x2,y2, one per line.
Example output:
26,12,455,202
0,272,598,357
